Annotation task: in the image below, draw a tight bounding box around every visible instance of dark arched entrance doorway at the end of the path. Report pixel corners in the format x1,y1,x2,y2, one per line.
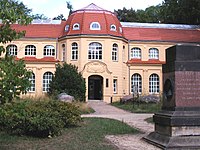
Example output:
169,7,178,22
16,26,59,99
88,75,103,100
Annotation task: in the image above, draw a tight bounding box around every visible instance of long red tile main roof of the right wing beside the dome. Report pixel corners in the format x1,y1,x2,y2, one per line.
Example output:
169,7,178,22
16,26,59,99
123,27,200,43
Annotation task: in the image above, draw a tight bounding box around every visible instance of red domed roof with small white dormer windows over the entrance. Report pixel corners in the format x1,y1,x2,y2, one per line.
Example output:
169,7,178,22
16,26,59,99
63,3,123,37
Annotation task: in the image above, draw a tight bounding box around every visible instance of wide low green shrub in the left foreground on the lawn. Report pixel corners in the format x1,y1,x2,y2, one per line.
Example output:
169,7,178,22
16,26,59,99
0,101,81,137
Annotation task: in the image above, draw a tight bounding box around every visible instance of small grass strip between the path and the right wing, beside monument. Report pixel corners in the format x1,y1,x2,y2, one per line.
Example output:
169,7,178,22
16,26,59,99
111,102,161,113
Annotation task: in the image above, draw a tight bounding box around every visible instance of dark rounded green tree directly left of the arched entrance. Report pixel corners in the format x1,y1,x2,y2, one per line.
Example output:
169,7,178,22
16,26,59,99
49,63,86,101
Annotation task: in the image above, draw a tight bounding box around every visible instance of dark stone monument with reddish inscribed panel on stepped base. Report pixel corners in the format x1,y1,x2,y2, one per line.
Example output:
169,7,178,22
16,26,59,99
144,45,200,150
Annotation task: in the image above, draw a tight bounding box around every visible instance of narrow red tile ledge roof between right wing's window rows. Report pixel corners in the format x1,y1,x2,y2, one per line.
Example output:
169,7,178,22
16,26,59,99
127,59,166,65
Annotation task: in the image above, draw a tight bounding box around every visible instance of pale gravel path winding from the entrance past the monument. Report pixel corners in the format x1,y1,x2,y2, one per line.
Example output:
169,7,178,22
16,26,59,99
82,101,160,150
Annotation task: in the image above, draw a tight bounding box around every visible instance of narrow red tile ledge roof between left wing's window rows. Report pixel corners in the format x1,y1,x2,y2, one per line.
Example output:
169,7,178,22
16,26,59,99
15,57,59,62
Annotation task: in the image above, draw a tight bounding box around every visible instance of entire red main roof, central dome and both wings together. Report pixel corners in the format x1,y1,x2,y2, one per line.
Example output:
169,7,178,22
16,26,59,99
1,4,200,43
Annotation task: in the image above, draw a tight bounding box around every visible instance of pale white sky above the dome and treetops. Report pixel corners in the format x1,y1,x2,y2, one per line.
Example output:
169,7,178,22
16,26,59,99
19,0,162,18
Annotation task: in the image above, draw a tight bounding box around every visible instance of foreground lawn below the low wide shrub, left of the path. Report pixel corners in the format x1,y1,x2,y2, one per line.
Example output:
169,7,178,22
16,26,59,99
0,118,139,150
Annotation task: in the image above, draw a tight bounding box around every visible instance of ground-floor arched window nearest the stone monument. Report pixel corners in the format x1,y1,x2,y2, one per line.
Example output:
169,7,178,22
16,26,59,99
149,74,160,94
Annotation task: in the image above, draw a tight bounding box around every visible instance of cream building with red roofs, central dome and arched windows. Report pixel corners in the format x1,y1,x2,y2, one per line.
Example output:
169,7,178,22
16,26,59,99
1,4,200,102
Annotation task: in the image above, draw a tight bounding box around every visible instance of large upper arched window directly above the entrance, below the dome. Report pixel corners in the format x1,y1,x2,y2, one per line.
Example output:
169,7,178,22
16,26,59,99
88,42,102,60
